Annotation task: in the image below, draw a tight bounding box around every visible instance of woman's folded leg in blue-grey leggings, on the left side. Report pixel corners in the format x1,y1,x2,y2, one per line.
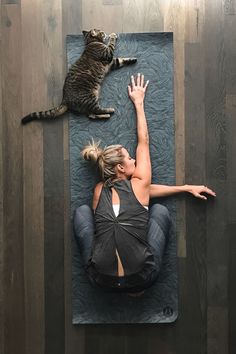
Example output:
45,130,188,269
74,205,95,264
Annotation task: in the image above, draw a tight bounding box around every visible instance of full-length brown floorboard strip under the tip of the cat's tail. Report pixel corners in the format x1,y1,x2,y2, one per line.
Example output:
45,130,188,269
19,0,46,354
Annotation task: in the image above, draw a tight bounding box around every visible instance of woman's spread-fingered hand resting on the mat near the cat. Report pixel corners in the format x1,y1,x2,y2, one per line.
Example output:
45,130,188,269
128,73,149,106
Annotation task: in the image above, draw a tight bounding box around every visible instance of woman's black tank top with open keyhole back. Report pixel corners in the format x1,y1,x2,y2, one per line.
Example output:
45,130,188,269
87,180,155,291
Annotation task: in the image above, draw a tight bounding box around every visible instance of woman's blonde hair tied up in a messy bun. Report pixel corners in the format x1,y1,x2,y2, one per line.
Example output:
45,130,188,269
81,140,124,182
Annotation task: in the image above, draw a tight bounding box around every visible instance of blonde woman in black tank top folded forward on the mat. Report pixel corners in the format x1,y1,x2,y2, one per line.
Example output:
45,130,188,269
74,74,215,293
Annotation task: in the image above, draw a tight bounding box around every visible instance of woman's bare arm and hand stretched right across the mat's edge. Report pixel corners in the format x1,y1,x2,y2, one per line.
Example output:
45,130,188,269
149,184,216,200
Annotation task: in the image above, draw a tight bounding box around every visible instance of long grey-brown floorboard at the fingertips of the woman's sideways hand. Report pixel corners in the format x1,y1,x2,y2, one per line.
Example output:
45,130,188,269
205,1,228,288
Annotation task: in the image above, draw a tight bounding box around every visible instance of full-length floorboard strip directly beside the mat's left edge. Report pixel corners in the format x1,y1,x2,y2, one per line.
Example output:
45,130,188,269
43,0,65,354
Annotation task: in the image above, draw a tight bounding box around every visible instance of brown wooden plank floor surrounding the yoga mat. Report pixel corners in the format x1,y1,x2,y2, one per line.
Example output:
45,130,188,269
0,0,236,354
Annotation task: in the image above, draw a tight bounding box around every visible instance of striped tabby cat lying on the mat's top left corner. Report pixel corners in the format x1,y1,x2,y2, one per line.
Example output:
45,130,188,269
21,29,137,124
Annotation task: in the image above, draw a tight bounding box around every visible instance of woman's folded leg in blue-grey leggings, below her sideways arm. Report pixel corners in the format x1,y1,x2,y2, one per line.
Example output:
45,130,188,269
148,204,171,273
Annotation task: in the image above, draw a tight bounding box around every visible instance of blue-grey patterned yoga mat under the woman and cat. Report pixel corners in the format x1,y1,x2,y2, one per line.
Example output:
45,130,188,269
67,33,178,324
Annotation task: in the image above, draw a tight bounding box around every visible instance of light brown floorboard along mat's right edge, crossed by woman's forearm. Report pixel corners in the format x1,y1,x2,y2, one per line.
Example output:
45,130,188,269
164,0,186,257
